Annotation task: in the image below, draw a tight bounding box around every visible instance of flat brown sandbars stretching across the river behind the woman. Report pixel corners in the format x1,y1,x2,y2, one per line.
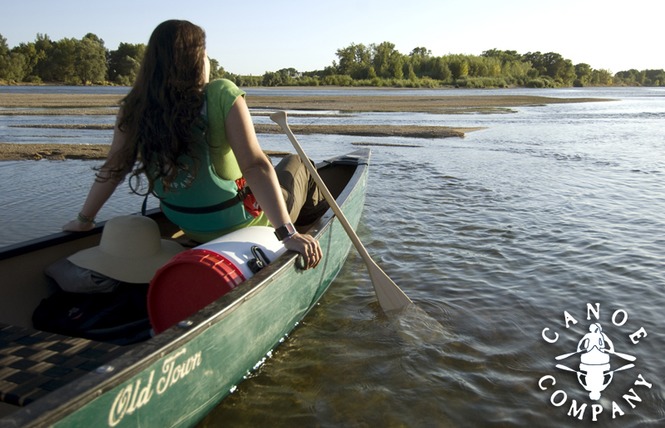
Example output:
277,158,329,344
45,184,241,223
0,93,606,160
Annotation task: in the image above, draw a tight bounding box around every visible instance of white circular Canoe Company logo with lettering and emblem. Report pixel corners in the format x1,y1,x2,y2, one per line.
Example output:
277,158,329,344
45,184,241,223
538,303,653,422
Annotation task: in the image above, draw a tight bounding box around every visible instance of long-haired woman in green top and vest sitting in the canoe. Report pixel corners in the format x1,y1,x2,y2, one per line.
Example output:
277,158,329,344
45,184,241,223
64,20,327,268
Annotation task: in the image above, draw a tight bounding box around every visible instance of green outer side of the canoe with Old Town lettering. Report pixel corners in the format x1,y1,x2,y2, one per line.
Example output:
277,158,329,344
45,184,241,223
0,152,369,427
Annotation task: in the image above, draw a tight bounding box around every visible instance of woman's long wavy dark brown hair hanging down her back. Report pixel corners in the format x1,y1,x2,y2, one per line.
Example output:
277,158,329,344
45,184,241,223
98,20,205,193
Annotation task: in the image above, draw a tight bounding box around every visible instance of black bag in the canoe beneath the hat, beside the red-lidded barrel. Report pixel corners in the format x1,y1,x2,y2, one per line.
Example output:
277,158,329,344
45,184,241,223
32,283,151,345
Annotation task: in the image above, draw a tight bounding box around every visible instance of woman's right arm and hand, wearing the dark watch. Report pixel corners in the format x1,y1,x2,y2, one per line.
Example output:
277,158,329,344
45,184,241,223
226,97,322,268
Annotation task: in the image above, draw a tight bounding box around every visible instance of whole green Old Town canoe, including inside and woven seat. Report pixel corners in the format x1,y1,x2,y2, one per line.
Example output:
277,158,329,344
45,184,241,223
0,150,369,427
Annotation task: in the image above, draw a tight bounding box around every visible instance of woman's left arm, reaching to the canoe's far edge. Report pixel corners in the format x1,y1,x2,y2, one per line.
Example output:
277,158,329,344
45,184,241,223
62,114,125,232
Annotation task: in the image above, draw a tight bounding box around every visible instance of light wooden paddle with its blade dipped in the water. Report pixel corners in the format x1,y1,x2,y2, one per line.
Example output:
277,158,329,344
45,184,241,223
270,111,412,312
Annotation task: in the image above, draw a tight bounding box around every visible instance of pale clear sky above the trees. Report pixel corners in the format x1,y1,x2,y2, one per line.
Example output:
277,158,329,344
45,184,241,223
0,0,665,75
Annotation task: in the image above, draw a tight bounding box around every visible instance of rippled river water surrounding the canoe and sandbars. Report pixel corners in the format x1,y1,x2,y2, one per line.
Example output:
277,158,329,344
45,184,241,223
0,88,665,427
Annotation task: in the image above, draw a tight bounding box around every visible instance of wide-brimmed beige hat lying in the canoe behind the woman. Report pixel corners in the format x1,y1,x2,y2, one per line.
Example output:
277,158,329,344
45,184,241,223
68,215,184,284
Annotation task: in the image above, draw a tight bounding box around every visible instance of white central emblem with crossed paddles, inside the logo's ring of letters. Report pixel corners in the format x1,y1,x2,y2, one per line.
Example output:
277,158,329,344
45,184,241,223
555,323,635,400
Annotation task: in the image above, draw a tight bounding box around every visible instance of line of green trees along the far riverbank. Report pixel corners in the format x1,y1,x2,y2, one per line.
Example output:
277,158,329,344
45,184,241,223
0,33,665,88
